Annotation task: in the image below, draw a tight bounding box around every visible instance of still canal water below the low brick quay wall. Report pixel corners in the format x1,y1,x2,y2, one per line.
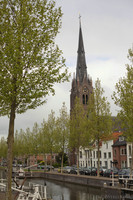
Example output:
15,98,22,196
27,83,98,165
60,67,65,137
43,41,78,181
0,171,121,200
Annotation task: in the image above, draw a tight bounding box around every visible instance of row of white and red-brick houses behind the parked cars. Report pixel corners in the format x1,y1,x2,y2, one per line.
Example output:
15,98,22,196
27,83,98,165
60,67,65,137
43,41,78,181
79,132,132,169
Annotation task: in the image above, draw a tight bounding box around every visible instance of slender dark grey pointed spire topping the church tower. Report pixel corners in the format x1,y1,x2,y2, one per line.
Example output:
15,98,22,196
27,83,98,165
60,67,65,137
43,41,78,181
76,17,87,84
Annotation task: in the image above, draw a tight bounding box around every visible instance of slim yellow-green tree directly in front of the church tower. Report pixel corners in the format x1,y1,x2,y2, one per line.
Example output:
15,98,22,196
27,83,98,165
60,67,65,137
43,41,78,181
69,97,89,174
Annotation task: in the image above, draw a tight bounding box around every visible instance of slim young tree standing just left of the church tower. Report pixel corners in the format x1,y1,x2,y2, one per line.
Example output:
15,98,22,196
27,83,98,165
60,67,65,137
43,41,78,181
57,103,70,173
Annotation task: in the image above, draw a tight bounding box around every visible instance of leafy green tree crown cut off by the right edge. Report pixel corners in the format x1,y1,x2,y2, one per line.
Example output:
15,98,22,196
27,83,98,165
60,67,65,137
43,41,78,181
112,49,133,170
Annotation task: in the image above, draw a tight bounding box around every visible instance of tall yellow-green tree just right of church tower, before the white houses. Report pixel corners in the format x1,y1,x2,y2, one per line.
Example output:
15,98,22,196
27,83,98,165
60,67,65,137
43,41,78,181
88,79,112,176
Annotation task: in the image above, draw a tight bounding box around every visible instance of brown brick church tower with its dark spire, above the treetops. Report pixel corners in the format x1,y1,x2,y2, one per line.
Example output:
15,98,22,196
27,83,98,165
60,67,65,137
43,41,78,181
70,19,93,113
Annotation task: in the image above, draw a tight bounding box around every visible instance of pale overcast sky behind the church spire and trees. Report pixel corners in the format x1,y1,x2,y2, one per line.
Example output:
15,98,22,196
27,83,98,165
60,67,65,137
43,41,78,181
0,0,133,138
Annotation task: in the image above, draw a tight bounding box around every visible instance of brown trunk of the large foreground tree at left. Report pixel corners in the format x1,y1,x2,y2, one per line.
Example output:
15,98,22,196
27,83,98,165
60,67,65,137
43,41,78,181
6,103,15,200
